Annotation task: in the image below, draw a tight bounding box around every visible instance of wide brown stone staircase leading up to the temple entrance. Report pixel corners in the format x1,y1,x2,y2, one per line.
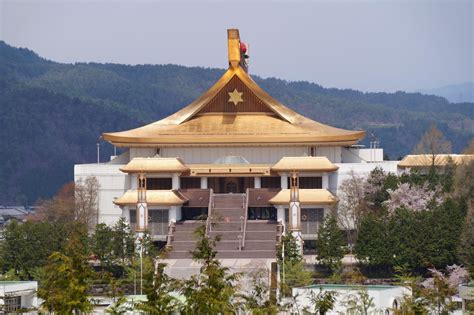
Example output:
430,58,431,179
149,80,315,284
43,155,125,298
168,194,277,259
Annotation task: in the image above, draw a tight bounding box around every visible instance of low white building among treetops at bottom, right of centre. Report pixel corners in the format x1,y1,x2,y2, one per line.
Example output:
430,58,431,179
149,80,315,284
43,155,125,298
293,284,411,315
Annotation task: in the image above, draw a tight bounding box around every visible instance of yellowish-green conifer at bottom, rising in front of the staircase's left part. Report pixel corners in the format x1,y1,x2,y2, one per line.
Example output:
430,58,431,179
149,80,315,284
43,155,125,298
182,225,240,314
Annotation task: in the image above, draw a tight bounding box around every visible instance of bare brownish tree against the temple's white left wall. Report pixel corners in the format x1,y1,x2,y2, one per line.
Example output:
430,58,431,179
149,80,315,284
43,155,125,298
74,176,100,230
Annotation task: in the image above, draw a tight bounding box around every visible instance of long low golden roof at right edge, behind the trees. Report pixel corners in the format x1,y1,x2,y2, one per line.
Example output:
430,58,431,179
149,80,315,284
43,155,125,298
398,154,474,168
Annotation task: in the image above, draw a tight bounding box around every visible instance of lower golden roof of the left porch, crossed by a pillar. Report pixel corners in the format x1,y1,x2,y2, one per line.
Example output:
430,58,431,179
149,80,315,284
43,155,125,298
114,189,188,206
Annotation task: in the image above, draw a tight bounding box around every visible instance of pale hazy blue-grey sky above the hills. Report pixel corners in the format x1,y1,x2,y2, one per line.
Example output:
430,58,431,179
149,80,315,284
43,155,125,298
0,0,474,91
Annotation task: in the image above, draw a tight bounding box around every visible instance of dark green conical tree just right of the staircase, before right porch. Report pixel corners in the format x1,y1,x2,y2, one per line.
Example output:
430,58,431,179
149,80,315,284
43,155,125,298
316,215,346,271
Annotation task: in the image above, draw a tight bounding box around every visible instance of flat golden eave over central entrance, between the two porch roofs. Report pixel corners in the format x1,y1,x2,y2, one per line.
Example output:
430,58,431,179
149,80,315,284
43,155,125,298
189,164,270,177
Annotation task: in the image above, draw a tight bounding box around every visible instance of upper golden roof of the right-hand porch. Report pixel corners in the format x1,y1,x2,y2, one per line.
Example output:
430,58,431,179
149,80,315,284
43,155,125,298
272,156,339,172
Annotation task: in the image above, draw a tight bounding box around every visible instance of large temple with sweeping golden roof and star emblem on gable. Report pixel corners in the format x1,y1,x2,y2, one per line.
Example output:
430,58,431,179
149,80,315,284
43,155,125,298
75,29,397,259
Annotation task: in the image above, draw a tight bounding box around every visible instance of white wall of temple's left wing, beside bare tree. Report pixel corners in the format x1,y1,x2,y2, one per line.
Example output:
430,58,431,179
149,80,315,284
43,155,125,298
74,164,131,224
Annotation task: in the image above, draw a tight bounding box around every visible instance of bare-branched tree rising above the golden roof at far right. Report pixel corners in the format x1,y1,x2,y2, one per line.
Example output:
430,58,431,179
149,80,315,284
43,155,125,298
413,125,451,168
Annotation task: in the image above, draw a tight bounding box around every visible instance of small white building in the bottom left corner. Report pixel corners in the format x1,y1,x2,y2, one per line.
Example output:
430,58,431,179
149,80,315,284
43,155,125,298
0,281,38,314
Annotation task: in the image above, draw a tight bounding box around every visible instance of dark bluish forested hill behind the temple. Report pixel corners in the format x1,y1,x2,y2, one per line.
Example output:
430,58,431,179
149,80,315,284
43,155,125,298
0,42,474,204
